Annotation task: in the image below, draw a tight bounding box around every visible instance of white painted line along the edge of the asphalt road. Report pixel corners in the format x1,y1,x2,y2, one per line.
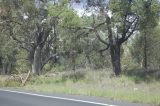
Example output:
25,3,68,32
0,89,117,106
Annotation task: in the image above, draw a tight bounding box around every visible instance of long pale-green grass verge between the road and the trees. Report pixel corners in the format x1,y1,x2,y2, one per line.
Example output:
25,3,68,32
0,69,160,106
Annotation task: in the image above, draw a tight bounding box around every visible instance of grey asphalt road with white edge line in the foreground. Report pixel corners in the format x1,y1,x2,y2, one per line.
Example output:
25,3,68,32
0,89,150,106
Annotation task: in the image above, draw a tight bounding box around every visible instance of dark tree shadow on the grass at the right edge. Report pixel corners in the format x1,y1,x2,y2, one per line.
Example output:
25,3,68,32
125,69,160,83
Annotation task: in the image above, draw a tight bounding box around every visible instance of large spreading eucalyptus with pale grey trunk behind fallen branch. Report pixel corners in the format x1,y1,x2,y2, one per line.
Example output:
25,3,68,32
1,0,71,74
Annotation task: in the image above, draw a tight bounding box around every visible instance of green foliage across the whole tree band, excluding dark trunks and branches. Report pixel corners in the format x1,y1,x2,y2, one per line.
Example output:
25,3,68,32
0,0,160,75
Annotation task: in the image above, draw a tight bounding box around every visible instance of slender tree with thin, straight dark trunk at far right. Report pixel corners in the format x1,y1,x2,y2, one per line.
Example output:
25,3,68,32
140,0,160,71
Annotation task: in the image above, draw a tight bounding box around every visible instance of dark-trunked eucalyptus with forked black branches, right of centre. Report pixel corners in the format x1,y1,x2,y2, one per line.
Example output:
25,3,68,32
98,0,139,75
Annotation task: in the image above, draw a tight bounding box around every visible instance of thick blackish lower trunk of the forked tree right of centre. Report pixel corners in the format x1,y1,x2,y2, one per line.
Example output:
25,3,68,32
110,44,121,76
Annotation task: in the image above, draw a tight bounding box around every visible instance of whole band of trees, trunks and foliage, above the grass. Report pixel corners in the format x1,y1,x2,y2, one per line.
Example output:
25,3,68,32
0,0,160,76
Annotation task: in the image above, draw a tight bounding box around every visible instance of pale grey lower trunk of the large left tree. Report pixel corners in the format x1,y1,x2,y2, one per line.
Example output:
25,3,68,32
32,46,42,75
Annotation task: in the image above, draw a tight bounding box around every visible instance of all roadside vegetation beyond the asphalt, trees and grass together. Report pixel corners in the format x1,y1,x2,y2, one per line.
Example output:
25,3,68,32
0,0,160,106
